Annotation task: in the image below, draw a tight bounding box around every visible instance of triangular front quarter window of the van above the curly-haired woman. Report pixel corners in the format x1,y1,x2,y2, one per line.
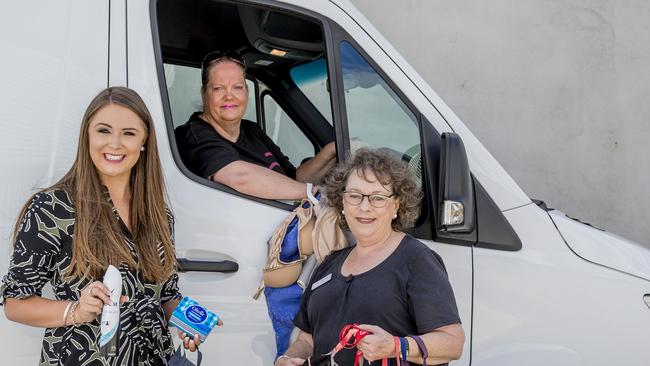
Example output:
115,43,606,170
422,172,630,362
340,41,422,183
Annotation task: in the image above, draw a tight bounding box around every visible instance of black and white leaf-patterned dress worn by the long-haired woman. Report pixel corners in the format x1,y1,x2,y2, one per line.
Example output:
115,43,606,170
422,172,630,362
0,190,182,366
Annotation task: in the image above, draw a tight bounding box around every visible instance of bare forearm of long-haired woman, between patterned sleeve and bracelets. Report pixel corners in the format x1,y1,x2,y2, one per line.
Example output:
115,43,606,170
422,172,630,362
4,295,72,328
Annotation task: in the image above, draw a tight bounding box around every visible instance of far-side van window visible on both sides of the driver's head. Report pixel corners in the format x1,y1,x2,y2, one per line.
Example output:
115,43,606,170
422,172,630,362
164,64,257,128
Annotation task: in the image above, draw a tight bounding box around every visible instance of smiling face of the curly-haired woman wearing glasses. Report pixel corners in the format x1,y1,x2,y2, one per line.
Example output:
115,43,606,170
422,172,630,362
343,171,399,245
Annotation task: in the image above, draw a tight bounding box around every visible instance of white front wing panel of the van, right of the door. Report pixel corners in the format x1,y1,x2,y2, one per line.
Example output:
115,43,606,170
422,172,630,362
472,204,650,366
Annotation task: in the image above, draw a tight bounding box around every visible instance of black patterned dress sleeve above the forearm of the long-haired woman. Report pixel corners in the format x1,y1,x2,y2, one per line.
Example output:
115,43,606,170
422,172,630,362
0,192,74,301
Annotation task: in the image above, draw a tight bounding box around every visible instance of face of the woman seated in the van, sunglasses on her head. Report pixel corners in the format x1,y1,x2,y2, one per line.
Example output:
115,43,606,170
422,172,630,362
203,60,248,128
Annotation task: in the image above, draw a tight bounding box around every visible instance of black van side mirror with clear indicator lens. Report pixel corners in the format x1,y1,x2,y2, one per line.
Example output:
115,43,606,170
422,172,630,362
438,132,475,233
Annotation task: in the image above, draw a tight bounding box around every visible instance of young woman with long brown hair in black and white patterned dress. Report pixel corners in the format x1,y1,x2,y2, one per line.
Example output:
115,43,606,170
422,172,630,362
0,87,198,365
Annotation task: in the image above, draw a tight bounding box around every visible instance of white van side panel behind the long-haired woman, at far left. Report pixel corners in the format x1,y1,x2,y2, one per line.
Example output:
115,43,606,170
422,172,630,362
0,0,109,365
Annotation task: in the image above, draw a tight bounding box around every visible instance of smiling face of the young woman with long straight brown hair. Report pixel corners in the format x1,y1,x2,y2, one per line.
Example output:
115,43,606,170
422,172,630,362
88,104,147,184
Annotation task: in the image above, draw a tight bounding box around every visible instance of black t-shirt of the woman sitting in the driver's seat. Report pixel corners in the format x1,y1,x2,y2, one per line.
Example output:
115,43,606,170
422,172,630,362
175,112,296,179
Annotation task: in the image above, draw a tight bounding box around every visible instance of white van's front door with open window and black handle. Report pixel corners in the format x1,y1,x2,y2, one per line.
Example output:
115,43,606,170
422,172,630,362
127,0,473,365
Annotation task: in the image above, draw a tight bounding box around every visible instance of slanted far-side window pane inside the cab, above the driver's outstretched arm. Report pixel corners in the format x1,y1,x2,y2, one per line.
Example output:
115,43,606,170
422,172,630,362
262,93,314,167
